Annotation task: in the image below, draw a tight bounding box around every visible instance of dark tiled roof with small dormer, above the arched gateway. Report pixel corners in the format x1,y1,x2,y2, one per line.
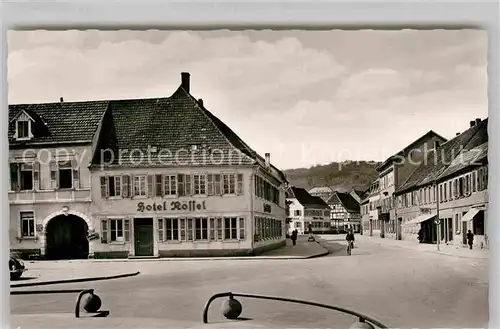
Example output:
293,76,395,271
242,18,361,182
9,101,108,147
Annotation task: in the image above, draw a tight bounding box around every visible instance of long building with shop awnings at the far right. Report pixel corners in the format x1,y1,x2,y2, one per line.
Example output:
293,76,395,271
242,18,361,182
395,119,488,245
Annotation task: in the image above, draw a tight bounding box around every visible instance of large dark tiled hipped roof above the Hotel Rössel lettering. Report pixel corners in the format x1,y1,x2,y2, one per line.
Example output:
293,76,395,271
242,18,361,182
87,74,286,181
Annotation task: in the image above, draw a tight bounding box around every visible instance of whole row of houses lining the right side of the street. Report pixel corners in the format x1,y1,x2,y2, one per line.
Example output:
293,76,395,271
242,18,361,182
361,118,488,248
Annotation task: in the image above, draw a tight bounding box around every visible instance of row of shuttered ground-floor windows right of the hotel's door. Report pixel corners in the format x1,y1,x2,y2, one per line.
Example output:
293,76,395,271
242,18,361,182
158,217,245,242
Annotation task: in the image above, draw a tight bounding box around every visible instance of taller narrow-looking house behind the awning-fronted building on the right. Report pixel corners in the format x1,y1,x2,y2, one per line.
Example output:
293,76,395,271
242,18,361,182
370,130,446,240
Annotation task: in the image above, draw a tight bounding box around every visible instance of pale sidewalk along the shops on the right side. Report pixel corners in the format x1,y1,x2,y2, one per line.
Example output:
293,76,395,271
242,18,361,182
321,234,489,259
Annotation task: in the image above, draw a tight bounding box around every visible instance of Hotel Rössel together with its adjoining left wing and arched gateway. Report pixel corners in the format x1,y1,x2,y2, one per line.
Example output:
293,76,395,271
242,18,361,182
8,73,288,259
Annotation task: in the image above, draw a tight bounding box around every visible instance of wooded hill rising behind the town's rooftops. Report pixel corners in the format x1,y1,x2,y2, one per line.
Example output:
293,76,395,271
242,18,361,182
284,161,380,192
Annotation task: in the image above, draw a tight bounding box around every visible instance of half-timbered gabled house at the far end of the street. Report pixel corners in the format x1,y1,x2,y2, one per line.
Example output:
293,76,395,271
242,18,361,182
326,192,361,233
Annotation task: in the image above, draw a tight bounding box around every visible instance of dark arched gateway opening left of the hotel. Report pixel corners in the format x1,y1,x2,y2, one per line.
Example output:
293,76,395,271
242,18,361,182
46,214,89,260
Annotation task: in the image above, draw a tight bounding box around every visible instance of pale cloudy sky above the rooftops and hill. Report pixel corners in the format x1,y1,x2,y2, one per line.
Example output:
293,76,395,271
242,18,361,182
7,30,488,169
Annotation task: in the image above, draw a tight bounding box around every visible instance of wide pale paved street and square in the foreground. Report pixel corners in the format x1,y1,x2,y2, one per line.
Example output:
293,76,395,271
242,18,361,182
11,236,488,328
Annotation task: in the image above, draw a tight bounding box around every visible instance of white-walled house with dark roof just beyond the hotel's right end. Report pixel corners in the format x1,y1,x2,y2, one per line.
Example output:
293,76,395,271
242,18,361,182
287,186,330,234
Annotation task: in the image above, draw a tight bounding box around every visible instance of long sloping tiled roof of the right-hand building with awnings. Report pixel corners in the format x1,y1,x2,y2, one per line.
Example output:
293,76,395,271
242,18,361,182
395,119,488,194
